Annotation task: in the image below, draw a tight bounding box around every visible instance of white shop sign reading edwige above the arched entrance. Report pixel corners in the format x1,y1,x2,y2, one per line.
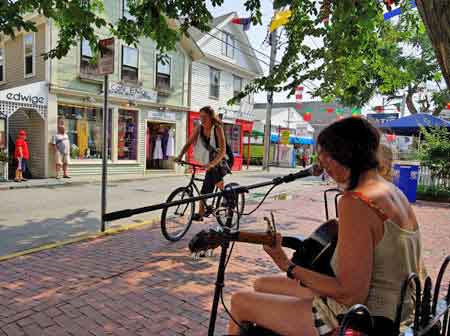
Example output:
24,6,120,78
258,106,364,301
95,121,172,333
0,81,48,105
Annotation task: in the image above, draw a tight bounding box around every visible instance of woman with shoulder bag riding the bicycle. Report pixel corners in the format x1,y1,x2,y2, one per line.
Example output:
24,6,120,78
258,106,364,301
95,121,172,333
177,106,227,221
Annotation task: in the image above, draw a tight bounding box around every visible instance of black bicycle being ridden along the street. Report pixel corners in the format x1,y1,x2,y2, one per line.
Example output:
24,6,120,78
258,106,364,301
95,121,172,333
161,161,245,242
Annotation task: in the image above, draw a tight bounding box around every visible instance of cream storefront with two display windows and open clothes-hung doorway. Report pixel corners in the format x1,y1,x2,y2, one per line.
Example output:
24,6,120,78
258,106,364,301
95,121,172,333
50,84,187,176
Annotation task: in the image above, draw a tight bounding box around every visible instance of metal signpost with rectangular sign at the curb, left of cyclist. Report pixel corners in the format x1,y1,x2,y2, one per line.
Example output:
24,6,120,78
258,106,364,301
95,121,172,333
97,38,114,232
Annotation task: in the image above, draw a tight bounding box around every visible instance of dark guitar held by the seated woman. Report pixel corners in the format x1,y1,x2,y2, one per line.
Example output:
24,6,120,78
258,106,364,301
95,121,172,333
189,219,338,276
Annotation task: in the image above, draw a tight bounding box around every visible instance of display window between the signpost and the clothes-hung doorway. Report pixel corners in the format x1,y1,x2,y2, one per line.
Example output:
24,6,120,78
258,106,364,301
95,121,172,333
117,110,138,160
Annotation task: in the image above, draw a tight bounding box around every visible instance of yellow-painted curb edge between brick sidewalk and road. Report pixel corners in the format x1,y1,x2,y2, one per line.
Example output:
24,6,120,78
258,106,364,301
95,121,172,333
0,216,160,262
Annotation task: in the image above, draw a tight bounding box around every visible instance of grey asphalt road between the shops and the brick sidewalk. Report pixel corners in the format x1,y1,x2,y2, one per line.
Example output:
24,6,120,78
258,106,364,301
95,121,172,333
0,169,317,256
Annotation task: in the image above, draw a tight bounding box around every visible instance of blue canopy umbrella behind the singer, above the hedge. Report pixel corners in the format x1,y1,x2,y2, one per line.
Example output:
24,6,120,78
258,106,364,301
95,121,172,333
379,113,450,136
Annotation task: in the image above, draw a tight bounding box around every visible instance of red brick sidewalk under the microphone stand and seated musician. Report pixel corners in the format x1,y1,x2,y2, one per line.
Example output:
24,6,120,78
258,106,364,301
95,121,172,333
0,186,450,336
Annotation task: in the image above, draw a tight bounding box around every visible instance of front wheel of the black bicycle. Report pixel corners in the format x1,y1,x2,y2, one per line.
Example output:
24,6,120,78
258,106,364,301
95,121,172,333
161,187,195,241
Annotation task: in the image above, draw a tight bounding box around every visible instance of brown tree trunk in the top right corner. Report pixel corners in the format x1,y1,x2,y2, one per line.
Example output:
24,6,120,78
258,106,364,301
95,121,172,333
416,0,450,89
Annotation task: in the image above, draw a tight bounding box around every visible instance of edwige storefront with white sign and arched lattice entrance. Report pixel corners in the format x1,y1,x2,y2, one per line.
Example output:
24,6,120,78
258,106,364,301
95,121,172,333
0,81,48,180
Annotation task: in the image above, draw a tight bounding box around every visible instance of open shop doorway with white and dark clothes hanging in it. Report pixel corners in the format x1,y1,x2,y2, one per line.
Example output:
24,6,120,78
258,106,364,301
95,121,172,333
145,121,176,169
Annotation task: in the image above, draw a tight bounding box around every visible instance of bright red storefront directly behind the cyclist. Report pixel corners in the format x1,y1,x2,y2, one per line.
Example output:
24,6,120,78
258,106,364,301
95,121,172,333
188,111,253,171
